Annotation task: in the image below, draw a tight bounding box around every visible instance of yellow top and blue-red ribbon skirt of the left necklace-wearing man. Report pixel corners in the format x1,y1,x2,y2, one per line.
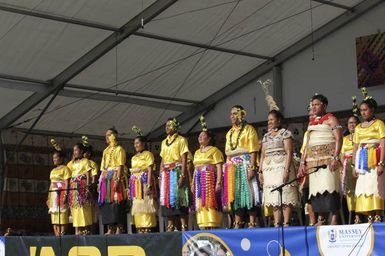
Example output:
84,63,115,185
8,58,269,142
160,133,189,213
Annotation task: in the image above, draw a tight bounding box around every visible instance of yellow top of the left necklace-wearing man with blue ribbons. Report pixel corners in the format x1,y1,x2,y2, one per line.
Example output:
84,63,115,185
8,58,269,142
160,133,189,164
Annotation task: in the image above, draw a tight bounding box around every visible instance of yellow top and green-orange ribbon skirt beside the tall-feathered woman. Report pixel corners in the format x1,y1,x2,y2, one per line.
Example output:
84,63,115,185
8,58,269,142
223,124,261,210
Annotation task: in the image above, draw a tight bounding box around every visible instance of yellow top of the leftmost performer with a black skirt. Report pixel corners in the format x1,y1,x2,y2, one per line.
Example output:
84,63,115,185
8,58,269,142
100,145,126,171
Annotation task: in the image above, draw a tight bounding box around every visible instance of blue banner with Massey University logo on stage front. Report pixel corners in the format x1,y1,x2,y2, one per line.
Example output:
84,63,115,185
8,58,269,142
182,223,385,256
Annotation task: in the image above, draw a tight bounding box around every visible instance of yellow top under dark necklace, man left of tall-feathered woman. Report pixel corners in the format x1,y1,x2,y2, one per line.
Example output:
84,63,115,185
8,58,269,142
225,124,259,156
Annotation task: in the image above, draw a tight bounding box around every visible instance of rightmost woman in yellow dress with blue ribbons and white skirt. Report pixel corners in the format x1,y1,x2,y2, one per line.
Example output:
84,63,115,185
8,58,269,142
353,89,385,223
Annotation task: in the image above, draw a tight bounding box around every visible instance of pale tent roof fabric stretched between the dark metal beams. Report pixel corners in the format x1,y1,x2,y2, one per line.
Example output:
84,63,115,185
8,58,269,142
0,0,374,137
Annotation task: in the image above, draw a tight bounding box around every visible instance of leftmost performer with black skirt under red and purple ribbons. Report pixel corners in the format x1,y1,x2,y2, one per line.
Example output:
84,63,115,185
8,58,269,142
98,128,128,235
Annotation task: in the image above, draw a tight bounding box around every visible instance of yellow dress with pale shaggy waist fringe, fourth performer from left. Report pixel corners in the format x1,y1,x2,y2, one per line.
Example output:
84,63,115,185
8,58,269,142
130,150,156,228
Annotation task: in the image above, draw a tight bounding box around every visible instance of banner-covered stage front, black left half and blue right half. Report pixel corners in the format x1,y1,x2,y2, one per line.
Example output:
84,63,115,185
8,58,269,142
0,223,385,256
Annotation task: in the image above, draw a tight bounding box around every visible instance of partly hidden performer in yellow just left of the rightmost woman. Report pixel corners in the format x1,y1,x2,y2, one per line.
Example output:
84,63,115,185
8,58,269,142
340,96,360,224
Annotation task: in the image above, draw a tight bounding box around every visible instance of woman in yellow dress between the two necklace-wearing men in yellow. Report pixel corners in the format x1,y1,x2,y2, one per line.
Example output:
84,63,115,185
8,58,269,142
192,116,224,229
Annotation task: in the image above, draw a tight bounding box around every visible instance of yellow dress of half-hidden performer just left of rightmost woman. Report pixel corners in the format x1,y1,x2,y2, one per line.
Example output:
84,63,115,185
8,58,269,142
340,134,356,212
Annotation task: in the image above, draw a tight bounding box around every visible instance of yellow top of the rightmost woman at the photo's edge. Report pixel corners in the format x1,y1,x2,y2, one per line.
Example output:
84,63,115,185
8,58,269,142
353,119,385,144
